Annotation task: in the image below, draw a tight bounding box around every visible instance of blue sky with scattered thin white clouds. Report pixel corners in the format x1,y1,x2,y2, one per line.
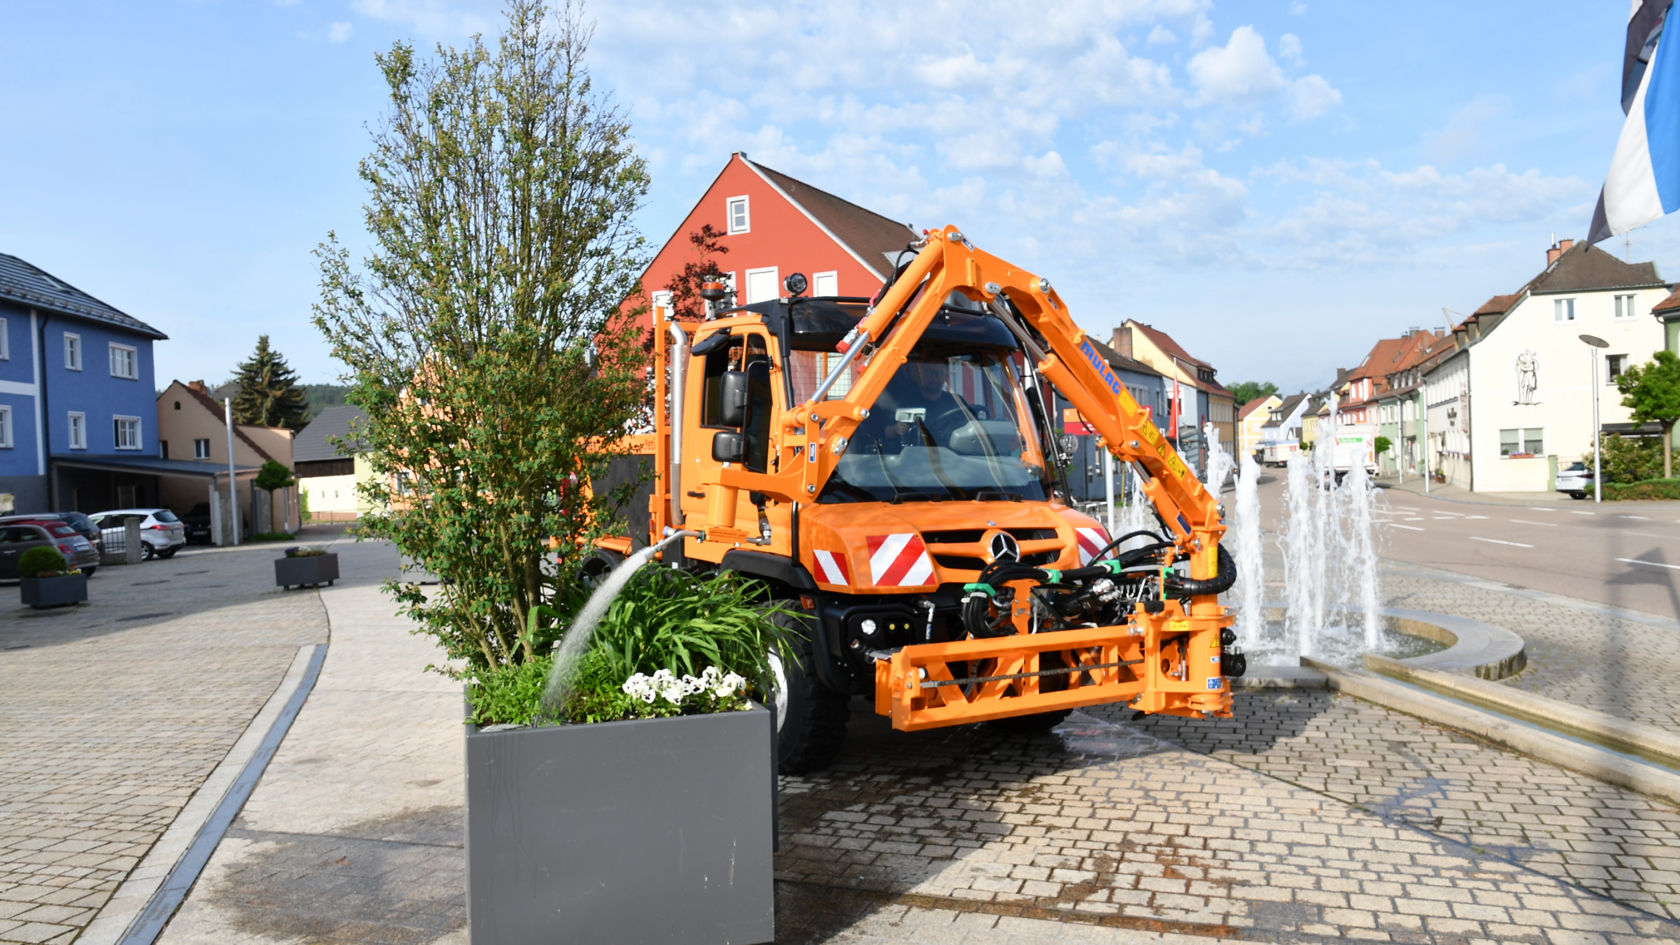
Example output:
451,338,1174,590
0,0,1680,390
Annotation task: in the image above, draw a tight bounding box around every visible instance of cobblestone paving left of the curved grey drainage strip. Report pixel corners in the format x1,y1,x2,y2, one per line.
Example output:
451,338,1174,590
0,538,328,943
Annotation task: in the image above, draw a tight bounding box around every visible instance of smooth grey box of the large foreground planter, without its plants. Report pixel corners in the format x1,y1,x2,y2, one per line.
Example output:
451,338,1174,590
467,706,776,945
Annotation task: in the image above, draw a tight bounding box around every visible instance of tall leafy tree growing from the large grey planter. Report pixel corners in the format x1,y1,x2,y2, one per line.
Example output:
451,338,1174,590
314,0,648,673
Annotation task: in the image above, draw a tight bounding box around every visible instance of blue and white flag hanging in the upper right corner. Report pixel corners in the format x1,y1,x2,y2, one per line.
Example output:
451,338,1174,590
1586,0,1680,244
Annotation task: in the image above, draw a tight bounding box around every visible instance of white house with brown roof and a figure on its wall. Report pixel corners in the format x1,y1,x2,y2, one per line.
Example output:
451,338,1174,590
1451,240,1670,493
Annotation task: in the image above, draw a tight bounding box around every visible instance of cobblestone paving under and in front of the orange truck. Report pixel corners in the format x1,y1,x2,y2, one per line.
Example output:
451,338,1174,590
776,693,1680,943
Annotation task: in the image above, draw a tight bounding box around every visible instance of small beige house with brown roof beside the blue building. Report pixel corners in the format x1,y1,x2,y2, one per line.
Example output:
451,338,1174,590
155,380,302,545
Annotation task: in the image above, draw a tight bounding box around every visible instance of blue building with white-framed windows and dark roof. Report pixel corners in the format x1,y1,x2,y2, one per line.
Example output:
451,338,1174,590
0,252,170,511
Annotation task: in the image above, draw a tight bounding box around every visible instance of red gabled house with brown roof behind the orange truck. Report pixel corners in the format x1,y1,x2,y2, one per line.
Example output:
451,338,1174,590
642,151,917,321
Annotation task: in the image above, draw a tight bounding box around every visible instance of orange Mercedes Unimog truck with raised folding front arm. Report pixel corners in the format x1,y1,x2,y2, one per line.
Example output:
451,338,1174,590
620,227,1243,773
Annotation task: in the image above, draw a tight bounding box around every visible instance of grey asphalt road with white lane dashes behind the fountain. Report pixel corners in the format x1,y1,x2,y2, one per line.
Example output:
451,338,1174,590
1256,469,1680,629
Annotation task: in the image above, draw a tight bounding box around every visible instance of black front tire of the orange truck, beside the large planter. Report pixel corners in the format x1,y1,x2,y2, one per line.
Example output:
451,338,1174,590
768,601,852,775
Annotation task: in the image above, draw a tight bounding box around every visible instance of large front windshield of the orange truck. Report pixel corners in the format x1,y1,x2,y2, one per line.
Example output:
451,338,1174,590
790,348,1050,503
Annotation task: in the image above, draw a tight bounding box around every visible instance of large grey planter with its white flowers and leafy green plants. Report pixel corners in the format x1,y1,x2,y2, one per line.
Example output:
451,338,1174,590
467,567,791,945
